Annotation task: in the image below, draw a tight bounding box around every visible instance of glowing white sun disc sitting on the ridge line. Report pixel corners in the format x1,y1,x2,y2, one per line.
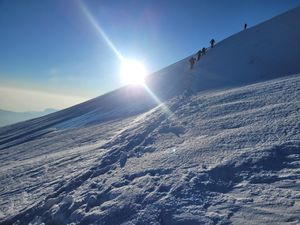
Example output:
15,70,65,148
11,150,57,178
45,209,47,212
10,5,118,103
121,59,147,85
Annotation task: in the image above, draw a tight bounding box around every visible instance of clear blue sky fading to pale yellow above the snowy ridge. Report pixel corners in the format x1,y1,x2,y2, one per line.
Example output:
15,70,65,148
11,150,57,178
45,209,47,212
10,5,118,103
0,0,300,111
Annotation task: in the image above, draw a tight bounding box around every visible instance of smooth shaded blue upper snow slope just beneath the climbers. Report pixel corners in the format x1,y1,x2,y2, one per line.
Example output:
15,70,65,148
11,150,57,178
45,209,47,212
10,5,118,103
146,7,300,92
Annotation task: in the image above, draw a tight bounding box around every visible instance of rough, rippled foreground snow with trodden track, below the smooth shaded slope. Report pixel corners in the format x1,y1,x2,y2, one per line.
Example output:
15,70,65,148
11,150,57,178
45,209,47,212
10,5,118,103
0,75,300,224
